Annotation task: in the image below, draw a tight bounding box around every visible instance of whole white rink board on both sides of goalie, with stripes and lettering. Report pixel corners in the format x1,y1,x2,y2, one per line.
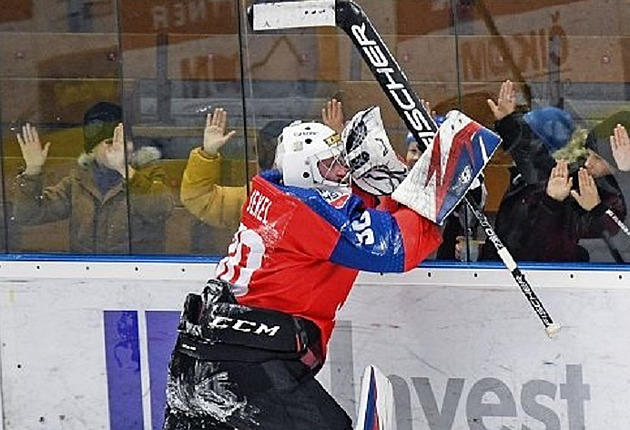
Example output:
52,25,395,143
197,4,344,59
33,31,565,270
0,265,630,430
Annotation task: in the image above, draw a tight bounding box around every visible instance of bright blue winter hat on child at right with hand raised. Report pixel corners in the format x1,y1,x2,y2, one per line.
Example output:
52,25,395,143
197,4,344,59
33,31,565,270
523,106,575,152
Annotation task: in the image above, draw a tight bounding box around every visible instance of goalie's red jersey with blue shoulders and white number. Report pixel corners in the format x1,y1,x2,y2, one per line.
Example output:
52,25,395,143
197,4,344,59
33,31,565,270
216,170,441,351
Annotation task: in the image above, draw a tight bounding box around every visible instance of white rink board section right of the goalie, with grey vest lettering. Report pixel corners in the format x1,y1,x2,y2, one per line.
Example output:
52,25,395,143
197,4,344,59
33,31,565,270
331,278,630,430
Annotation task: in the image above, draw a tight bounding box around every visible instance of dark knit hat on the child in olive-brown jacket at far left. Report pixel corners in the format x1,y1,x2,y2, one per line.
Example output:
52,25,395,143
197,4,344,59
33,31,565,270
83,102,122,153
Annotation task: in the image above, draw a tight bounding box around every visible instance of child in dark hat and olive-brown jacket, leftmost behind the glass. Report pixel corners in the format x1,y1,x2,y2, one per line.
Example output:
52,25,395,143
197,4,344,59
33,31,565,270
14,102,173,254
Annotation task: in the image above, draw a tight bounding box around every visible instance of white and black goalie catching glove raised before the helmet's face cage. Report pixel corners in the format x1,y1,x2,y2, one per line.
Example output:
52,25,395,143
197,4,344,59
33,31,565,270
341,106,407,196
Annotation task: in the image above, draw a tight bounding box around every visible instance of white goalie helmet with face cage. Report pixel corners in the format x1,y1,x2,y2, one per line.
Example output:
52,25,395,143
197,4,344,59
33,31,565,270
275,121,350,188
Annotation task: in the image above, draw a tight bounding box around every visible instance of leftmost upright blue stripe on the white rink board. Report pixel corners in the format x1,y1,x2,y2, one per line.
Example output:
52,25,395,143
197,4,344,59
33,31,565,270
104,311,144,430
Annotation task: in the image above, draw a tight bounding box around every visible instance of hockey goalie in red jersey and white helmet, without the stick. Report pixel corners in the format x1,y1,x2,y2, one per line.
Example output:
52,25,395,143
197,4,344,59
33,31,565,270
164,108,498,430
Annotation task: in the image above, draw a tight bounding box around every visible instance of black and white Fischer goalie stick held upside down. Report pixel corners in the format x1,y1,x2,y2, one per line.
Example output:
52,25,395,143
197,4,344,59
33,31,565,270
248,0,560,337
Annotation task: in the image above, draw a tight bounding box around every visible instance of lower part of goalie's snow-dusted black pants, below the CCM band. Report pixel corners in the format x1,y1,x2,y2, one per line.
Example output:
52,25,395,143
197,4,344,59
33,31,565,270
164,350,352,430
